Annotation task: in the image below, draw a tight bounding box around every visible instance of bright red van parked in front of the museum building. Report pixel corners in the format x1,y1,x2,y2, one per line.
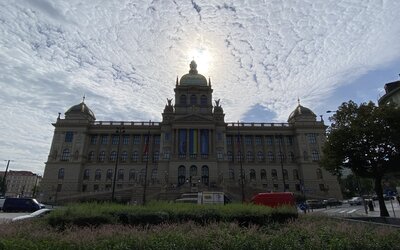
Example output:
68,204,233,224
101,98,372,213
251,192,296,207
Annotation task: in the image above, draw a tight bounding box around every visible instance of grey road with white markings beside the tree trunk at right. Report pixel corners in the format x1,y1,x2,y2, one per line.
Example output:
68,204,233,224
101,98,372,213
309,201,400,218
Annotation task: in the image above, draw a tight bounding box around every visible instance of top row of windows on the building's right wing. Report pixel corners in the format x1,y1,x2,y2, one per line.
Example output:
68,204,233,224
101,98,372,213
226,135,294,146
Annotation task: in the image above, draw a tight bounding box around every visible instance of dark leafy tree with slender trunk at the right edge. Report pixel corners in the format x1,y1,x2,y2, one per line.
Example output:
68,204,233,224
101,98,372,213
321,101,400,216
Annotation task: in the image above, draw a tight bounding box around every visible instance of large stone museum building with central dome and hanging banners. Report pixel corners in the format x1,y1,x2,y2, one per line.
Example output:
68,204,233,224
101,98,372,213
39,61,342,203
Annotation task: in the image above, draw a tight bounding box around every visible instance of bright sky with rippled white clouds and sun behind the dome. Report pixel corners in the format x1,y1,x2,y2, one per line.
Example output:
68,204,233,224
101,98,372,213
0,0,400,174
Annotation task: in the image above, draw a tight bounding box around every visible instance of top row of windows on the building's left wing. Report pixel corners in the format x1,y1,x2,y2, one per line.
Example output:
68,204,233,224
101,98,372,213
90,135,160,145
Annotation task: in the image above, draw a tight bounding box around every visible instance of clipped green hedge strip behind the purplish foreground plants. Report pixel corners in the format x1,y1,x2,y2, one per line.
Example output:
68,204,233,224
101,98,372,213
46,203,297,230
